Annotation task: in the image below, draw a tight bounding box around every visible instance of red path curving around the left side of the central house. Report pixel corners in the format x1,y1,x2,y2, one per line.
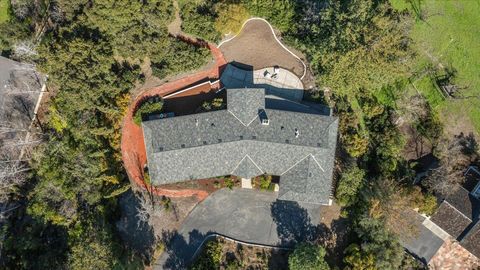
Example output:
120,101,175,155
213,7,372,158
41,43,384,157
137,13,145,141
121,40,226,200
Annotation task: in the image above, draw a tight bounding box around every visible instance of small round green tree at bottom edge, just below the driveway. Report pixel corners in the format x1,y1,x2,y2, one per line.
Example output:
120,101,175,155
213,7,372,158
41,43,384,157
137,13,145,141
288,243,330,270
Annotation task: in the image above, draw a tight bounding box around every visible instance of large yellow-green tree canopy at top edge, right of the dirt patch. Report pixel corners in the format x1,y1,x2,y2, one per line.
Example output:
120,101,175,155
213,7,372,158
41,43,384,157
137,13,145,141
289,0,411,96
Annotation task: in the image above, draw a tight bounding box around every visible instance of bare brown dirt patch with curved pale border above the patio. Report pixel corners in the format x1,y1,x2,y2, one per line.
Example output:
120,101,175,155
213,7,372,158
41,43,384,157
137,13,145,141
220,20,303,80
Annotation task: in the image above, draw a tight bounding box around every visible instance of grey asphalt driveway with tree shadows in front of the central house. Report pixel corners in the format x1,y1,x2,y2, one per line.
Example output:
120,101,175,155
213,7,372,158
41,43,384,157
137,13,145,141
155,189,320,269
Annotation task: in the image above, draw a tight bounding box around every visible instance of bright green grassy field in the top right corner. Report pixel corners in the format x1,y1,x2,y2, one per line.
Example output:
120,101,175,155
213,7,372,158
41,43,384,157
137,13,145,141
391,0,480,134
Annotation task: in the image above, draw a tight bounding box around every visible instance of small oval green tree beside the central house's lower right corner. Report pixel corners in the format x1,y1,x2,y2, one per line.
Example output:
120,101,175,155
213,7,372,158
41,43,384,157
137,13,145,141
336,166,365,207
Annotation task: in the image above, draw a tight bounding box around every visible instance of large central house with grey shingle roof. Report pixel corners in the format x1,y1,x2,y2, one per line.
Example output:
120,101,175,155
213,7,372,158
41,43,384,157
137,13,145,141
142,88,338,205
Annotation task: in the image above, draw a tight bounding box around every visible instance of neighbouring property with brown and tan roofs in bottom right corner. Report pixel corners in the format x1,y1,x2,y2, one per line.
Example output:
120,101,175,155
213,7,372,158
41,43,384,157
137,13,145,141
401,166,480,269
